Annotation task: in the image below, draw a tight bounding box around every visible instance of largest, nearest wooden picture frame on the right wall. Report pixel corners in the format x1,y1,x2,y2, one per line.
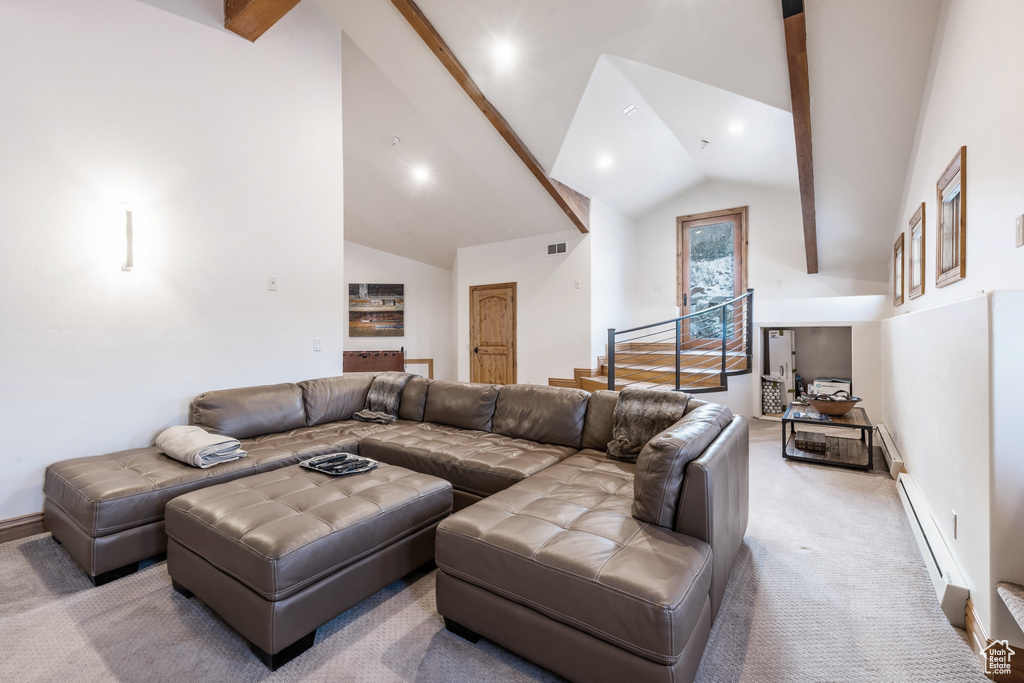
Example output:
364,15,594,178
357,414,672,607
935,146,967,287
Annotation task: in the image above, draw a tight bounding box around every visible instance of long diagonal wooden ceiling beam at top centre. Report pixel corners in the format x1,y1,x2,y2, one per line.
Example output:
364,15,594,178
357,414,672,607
391,0,590,232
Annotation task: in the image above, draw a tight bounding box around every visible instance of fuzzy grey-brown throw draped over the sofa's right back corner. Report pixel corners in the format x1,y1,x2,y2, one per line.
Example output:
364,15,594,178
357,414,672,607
608,387,690,463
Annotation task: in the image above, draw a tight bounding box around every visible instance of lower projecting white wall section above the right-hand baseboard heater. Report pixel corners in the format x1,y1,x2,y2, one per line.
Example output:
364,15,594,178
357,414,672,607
882,296,991,643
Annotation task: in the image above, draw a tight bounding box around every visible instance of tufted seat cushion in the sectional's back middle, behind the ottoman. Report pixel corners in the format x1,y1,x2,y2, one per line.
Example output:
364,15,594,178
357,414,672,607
359,421,575,496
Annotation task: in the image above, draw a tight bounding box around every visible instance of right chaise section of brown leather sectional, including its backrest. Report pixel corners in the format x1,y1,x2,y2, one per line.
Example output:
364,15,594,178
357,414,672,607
435,401,749,682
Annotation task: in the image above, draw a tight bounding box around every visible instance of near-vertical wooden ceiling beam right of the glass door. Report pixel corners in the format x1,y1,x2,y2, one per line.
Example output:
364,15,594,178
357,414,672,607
782,0,818,273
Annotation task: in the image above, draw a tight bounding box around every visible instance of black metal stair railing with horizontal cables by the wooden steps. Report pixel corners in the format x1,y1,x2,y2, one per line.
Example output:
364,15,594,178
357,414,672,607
607,290,754,393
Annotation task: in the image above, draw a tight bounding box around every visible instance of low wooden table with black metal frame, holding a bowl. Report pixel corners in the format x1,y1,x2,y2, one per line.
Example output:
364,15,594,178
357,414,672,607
782,403,874,470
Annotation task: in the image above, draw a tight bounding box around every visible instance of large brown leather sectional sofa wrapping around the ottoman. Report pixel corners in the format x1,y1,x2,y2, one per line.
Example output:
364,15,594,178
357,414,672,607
43,374,749,681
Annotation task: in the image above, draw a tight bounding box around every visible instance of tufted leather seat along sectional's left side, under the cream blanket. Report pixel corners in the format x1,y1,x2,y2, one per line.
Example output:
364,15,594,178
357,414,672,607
43,421,387,538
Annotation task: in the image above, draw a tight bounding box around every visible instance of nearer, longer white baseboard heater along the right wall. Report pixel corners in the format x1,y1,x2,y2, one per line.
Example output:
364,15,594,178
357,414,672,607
896,472,971,629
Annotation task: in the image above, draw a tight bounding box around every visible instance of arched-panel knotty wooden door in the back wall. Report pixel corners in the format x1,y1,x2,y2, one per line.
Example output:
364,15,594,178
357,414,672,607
469,283,516,384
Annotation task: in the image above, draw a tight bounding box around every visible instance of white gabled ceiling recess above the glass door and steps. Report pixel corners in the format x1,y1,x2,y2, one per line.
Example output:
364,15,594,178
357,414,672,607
552,55,797,217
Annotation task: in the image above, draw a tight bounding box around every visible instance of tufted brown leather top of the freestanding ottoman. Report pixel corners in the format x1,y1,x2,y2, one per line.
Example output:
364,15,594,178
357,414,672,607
167,465,452,600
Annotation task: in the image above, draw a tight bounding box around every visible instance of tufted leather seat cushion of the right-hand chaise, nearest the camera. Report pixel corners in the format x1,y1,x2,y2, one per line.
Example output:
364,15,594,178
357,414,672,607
436,451,712,665
